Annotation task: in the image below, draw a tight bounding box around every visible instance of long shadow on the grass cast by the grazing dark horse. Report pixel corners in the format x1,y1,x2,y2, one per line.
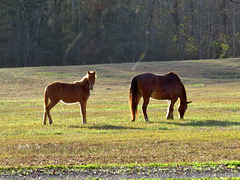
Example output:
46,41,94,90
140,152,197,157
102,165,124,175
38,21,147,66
168,120,240,127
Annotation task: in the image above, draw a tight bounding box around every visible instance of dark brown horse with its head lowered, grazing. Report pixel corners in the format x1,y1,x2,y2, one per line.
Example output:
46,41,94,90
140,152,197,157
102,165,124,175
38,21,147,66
129,72,190,122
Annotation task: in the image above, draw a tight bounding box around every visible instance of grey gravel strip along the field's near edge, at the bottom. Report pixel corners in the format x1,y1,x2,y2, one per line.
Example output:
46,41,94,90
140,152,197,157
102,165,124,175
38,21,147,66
0,165,240,179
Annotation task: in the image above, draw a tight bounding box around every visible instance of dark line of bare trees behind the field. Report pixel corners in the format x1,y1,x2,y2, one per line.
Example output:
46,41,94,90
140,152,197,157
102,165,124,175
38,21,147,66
0,0,240,67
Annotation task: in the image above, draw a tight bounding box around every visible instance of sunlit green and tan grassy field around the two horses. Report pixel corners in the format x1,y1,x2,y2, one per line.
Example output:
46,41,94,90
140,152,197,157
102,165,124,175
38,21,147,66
0,59,240,167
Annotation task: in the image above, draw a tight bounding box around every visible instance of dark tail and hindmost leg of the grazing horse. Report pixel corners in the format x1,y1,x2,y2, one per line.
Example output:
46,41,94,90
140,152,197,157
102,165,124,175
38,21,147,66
129,76,140,121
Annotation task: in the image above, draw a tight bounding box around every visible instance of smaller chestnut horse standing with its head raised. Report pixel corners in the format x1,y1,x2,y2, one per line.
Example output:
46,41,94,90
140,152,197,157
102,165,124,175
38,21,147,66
43,71,96,125
